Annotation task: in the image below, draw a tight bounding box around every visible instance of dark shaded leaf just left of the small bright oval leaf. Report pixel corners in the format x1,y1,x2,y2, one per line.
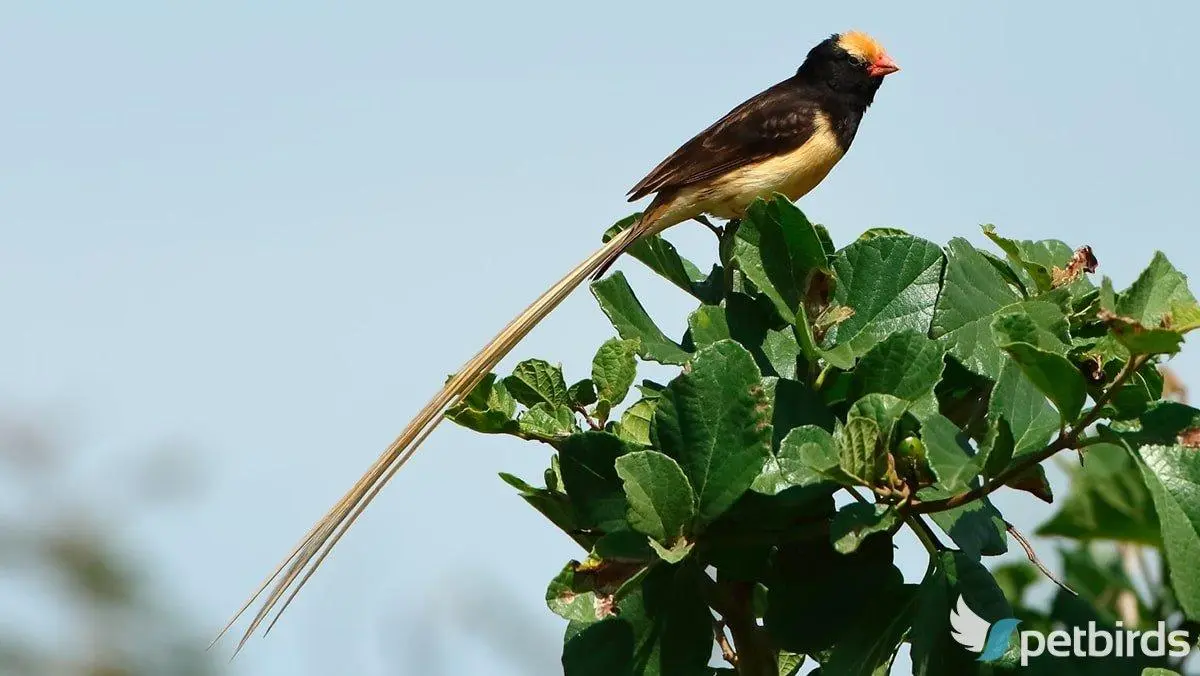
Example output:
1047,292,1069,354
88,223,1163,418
557,431,629,532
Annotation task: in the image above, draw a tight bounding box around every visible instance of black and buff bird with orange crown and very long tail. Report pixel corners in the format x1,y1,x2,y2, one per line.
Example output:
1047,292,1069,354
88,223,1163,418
214,31,900,654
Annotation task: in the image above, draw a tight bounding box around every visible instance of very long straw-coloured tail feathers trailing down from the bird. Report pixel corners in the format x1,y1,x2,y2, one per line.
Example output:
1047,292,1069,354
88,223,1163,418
210,219,646,654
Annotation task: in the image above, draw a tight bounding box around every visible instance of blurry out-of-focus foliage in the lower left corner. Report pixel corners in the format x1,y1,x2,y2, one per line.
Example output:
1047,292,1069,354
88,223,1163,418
0,420,216,676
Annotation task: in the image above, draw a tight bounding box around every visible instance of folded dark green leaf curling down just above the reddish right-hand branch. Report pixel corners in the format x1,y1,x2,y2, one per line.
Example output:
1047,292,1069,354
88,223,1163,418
992,315,1087,424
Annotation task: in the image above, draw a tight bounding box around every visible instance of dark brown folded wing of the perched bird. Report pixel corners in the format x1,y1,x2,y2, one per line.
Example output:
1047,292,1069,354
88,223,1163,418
629,80,821,202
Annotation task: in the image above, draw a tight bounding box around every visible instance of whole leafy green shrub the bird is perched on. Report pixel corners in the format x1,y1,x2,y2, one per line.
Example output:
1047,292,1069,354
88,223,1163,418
448,197,1200,676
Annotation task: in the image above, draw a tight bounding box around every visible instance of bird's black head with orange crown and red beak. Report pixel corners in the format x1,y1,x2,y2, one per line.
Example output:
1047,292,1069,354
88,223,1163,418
796,30,900,103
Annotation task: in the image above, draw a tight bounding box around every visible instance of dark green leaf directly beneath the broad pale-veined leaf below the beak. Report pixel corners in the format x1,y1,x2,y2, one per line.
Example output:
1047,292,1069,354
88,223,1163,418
851,330,944,418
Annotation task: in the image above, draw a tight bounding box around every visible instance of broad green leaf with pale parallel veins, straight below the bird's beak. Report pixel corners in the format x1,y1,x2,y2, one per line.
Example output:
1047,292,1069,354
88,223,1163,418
826,237,943,360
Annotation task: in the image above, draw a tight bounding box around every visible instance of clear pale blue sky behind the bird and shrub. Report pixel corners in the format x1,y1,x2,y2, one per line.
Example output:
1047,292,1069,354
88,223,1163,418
0,0,1200,676
